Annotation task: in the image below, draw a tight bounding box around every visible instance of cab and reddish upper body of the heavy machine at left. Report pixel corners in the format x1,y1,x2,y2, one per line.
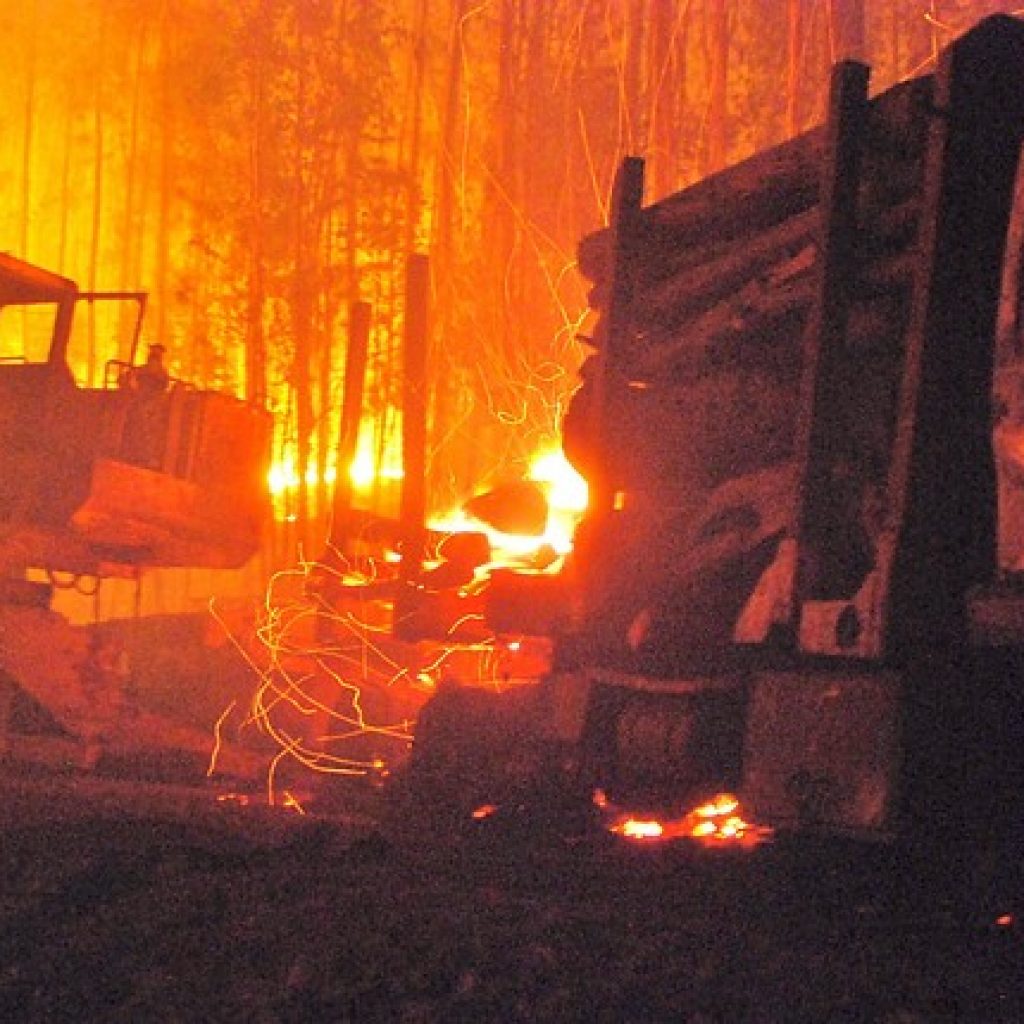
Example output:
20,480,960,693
0,254,270,574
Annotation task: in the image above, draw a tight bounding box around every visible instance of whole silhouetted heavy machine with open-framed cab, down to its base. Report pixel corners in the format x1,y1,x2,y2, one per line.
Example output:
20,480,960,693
0,254,271,761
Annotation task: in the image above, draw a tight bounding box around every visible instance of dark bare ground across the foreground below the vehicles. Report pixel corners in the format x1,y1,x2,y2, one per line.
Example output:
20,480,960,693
0,765,1024,1024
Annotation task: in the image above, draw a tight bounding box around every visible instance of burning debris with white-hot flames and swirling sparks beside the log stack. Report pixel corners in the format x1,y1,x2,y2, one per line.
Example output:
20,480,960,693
215,444,581,799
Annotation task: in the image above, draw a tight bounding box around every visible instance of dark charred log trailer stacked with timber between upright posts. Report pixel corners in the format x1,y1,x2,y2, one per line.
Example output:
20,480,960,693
414,16,1024,837
